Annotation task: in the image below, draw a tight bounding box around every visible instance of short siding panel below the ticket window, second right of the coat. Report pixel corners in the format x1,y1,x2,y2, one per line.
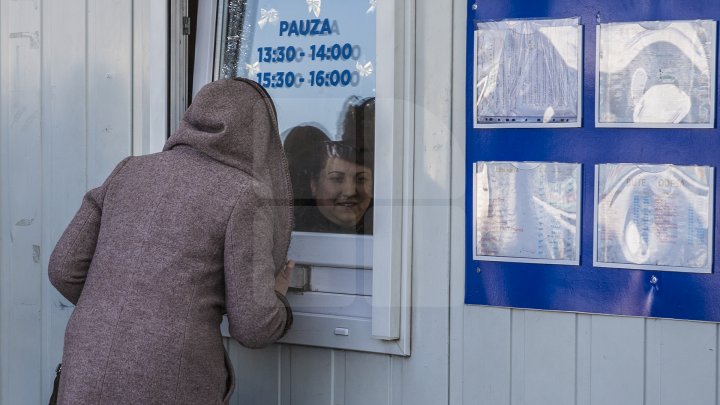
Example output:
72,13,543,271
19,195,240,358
290,346,332,405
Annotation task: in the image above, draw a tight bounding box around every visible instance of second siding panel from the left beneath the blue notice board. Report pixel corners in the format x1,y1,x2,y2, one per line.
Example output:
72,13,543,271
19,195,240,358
513,311,576,405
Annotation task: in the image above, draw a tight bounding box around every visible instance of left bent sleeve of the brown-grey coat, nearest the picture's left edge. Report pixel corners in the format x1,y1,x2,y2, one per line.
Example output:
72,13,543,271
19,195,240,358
48,158,130,305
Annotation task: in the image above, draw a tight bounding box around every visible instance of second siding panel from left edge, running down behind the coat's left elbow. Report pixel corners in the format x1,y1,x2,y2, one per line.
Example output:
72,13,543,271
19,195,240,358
41,0,87,398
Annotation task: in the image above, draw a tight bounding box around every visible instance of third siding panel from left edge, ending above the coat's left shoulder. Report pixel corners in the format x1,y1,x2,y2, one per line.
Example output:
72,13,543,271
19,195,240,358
87,0,133,188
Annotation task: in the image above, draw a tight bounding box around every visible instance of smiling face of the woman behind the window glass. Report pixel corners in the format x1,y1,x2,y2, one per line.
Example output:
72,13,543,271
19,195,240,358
310,157,373,228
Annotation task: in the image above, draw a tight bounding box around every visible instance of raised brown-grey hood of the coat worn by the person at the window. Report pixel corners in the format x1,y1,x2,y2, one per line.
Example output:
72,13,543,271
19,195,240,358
163,78,293,270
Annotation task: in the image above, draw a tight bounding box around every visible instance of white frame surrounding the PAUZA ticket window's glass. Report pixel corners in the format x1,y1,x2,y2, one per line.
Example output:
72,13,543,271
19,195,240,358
193,0,416,356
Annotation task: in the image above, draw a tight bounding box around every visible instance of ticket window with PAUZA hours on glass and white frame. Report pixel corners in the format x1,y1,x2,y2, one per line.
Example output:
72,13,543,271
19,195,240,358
186,0,411,355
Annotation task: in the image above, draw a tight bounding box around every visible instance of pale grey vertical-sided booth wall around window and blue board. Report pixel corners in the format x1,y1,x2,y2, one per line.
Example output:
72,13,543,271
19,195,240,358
0,0,720,405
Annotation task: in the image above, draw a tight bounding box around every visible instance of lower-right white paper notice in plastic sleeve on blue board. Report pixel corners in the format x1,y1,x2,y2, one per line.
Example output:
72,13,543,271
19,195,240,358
594,164,714,273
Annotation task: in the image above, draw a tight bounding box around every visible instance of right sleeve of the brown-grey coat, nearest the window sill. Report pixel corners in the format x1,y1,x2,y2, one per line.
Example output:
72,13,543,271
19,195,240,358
224,192,292,348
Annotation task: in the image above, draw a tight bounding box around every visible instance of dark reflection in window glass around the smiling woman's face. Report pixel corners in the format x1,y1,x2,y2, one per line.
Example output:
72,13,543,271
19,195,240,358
285,98,375,234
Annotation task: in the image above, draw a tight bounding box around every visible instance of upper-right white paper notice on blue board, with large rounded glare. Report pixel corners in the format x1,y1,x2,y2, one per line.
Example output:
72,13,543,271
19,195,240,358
597,20,716,127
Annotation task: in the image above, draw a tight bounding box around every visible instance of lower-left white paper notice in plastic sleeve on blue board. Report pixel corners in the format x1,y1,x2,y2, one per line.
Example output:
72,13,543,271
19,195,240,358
474,162,581,264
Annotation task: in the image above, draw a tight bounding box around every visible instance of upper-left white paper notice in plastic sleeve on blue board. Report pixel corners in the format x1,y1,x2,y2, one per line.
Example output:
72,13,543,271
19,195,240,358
474,18,582,127
